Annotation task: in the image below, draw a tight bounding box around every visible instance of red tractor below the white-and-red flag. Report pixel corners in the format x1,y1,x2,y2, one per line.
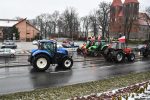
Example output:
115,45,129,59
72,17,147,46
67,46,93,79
104,41,135,62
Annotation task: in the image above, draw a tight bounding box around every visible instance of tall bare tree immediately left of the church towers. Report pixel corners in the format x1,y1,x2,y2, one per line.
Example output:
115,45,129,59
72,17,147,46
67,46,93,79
97,1,111,38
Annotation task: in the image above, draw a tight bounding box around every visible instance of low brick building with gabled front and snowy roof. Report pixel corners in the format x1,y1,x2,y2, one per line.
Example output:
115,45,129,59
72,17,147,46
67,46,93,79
0,19,40,41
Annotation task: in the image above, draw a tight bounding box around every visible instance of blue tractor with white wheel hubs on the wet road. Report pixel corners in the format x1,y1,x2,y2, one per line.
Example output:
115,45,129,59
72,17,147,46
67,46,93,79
28,40,73,71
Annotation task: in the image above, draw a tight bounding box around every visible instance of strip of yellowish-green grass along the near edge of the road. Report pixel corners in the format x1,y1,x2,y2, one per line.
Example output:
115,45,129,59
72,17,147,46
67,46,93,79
0,71,150,100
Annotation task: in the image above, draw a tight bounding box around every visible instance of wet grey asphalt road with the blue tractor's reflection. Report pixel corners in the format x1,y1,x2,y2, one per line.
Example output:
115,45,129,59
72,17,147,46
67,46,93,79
0,53,150,94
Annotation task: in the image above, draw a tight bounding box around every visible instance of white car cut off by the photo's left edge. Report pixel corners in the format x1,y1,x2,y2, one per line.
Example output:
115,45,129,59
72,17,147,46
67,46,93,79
0,48,16,57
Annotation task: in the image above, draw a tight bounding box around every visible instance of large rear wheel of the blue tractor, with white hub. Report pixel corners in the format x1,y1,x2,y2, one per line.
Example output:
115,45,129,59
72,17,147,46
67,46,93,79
33,54,50,71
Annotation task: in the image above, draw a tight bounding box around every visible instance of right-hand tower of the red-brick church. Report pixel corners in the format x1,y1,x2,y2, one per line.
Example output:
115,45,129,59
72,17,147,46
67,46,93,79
123,0,139,38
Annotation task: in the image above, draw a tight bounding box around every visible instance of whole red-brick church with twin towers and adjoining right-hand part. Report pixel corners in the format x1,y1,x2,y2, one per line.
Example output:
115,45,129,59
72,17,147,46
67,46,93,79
109,0,148,39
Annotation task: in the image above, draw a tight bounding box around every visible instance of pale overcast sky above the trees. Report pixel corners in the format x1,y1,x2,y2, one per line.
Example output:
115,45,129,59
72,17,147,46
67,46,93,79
0,0,150,19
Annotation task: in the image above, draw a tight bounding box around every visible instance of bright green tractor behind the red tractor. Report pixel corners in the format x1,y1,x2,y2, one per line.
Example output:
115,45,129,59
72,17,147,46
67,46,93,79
87,40,108,57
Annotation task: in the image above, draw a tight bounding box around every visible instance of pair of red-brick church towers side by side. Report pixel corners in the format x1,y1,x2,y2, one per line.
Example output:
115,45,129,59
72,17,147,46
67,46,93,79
109,0,139,37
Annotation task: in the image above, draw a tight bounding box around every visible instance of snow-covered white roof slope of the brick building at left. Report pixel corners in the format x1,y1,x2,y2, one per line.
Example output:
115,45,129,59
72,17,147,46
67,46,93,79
0,19,19,27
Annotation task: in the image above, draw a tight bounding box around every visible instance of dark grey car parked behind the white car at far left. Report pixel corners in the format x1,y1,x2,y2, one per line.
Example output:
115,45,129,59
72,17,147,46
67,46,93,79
1,40,17,49
